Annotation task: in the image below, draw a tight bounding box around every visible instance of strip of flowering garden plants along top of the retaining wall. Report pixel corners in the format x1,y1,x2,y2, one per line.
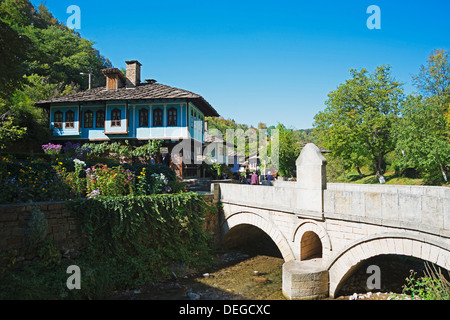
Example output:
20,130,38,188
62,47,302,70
0,156,186,203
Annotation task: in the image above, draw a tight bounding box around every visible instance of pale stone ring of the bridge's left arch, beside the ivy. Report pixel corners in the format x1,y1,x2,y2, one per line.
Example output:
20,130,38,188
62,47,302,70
221,211,295,262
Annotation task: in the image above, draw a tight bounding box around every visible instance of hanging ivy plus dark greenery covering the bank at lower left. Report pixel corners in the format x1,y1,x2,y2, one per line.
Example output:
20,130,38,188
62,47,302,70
0,193,217,299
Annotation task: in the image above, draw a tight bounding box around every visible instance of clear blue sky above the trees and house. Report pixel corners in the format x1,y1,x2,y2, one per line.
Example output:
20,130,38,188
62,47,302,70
32,0,450,129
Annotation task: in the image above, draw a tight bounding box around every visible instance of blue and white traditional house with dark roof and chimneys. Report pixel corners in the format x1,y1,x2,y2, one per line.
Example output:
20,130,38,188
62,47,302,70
36,60,219,178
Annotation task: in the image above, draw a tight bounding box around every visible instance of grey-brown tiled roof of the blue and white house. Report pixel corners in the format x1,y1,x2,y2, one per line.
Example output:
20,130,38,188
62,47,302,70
36,83,219,117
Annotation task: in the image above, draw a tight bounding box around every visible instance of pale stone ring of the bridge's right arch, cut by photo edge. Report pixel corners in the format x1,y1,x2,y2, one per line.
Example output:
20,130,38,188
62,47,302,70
328,233,450,297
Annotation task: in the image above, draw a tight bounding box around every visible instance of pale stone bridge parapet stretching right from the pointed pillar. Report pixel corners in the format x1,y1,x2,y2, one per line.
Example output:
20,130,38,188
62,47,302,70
324,183,450,238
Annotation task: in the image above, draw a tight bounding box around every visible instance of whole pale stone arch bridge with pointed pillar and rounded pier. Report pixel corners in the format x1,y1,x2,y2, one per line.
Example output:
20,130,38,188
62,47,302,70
212,144,450,299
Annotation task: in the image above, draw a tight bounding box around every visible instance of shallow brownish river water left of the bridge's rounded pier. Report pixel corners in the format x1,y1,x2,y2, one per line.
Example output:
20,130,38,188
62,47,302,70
110,251,285,300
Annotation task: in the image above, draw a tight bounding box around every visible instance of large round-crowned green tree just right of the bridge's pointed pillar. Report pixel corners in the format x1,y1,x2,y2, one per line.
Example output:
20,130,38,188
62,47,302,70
314,66,404,183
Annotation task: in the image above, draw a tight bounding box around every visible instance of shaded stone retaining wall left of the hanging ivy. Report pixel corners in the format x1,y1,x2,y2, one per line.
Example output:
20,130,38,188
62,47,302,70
0,202,82,263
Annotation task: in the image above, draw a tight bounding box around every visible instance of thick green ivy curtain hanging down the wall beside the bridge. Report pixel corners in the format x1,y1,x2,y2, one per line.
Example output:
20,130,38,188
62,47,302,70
68,193,214,288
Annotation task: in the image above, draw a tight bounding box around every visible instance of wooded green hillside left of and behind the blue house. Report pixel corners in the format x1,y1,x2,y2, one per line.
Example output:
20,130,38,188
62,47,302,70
0,0,111,147
